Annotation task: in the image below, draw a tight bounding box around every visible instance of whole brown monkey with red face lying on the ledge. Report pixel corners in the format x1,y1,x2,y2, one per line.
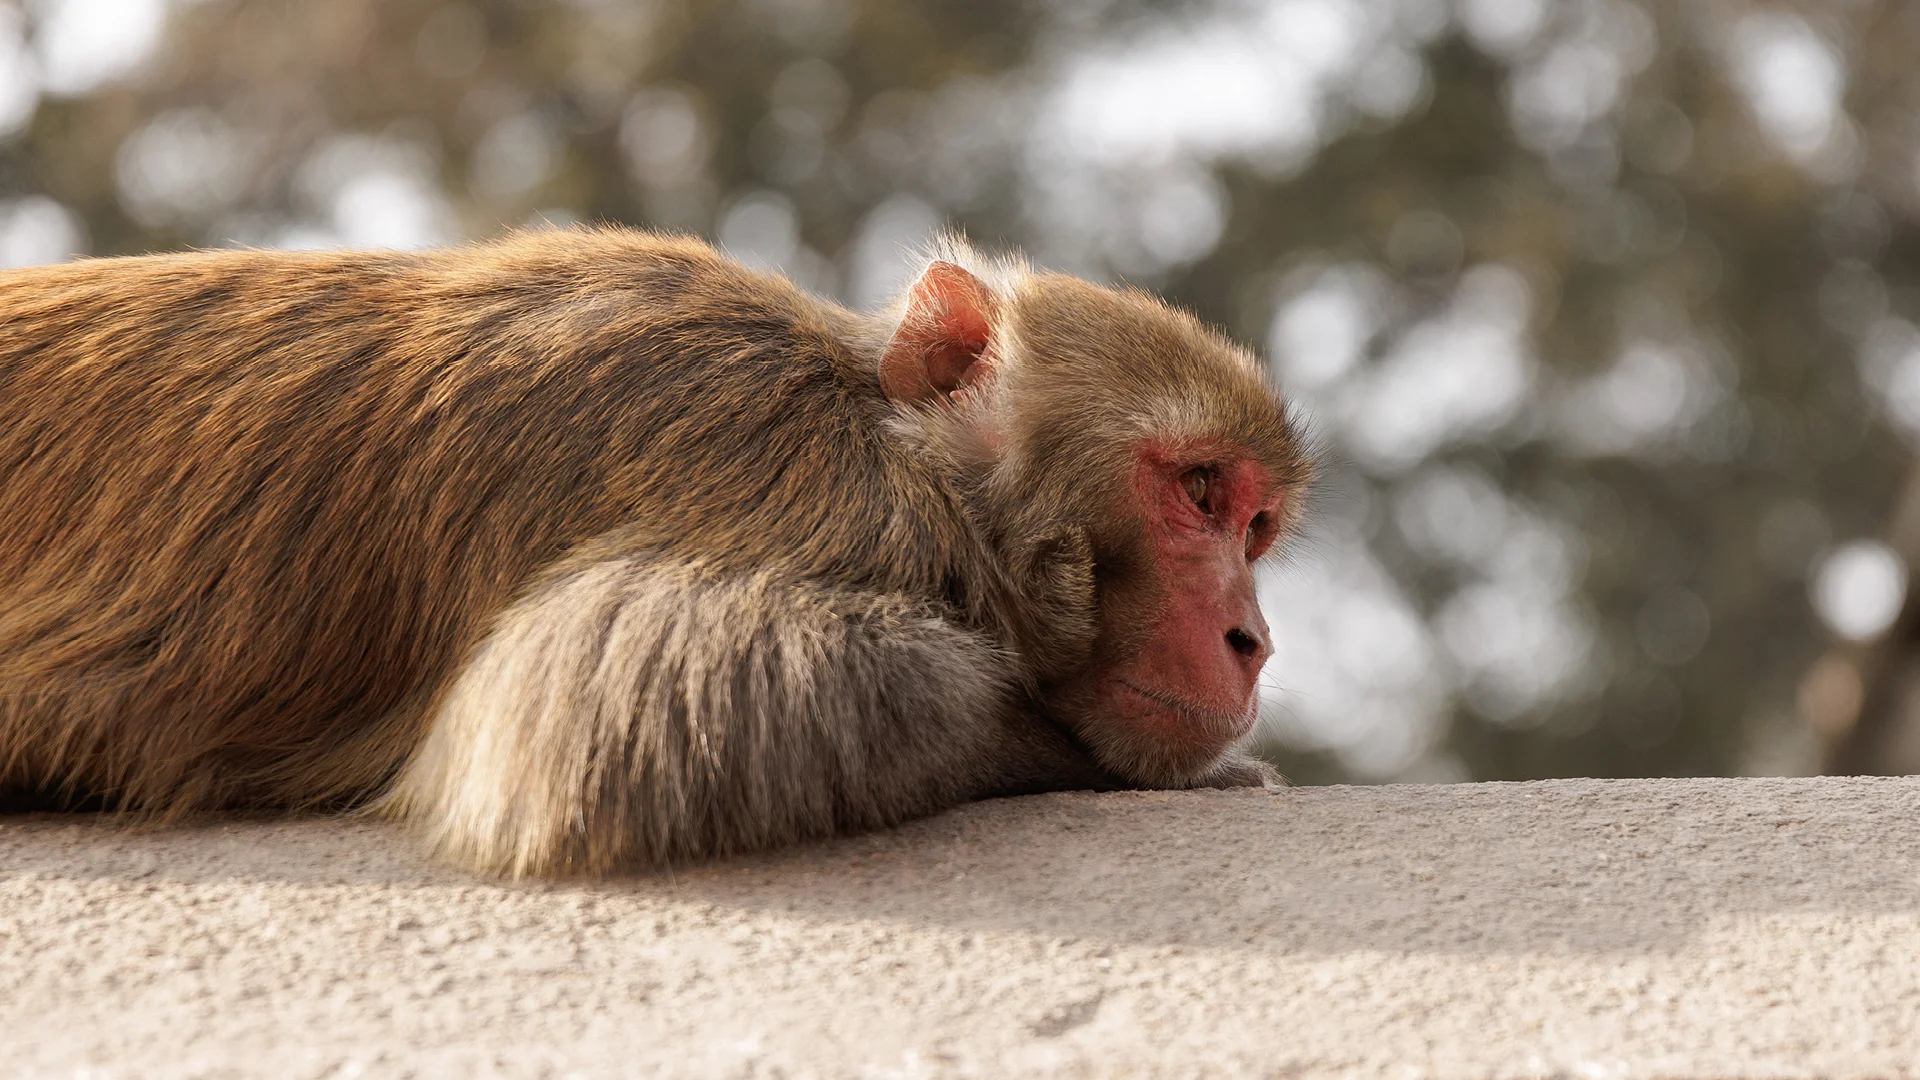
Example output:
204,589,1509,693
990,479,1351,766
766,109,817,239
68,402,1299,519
0,229,1309,874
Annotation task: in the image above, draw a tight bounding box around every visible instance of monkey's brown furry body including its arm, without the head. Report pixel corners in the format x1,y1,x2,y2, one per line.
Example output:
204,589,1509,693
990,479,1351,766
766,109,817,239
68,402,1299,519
0,231,1305,872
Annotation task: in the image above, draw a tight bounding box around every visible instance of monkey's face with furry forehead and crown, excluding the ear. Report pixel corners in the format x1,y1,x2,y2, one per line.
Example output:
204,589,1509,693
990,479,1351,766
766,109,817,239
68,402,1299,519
998,279,1311,786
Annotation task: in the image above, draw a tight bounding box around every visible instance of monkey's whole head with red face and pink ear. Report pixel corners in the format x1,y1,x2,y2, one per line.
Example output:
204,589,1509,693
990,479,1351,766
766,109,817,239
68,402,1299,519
879,246,1311,784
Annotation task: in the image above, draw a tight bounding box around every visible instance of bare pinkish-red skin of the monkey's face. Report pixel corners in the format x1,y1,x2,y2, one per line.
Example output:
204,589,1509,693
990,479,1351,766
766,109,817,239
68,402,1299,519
1100,448,1284,767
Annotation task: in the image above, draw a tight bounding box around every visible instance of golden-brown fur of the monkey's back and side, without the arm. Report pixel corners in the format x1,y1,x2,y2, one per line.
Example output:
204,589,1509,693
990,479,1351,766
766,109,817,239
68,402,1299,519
0,231,981,815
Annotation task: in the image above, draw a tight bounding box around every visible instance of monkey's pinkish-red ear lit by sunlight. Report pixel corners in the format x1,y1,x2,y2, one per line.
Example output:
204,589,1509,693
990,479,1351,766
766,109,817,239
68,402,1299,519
879,263,995,404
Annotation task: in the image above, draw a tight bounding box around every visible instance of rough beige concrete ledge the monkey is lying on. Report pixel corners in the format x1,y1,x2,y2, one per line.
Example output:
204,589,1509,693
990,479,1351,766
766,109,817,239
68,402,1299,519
0,778,1920,1078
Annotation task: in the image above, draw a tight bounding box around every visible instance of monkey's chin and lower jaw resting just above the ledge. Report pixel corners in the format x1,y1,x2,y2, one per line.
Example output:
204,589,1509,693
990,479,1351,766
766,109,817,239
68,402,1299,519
1079,676,1260,786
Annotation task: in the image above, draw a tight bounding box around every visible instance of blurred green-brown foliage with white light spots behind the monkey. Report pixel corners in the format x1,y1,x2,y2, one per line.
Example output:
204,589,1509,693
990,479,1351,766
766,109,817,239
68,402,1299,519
0,0,1920,782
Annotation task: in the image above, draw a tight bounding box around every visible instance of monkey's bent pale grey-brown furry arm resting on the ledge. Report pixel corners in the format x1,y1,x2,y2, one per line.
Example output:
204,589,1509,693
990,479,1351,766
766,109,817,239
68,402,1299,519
384,555,1098,874
